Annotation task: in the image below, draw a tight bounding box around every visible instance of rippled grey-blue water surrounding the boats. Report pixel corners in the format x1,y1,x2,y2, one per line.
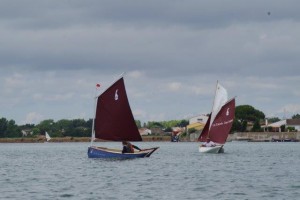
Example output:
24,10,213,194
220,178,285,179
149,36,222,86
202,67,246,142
0,142,300,200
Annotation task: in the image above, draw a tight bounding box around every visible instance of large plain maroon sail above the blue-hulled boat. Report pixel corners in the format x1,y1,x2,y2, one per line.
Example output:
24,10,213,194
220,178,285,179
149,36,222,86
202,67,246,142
94,77,142,141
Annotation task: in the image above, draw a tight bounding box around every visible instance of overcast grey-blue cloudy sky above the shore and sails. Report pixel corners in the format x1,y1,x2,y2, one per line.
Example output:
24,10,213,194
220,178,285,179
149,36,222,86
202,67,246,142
0,0,300,125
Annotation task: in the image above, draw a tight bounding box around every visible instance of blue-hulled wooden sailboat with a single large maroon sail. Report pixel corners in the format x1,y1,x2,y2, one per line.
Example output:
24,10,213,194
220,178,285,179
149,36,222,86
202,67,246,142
88,76,158,159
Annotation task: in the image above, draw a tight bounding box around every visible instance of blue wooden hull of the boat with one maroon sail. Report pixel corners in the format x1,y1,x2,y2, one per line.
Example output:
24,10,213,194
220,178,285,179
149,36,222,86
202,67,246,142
88,146,159,159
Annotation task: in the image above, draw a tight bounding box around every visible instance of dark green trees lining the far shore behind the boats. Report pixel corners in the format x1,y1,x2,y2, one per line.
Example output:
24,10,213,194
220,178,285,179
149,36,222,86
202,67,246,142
0,105,300,138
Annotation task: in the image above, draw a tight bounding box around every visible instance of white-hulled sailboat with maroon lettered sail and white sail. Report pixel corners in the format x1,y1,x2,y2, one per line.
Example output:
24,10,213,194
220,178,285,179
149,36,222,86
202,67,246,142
198,83,235,153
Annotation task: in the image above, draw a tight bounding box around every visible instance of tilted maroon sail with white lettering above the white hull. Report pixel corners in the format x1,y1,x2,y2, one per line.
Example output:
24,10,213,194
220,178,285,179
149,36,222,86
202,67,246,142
208,98,235,144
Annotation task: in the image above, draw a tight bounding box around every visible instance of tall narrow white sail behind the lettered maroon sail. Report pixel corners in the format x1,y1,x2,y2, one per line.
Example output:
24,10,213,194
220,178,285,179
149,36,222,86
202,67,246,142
209,82,228,128
